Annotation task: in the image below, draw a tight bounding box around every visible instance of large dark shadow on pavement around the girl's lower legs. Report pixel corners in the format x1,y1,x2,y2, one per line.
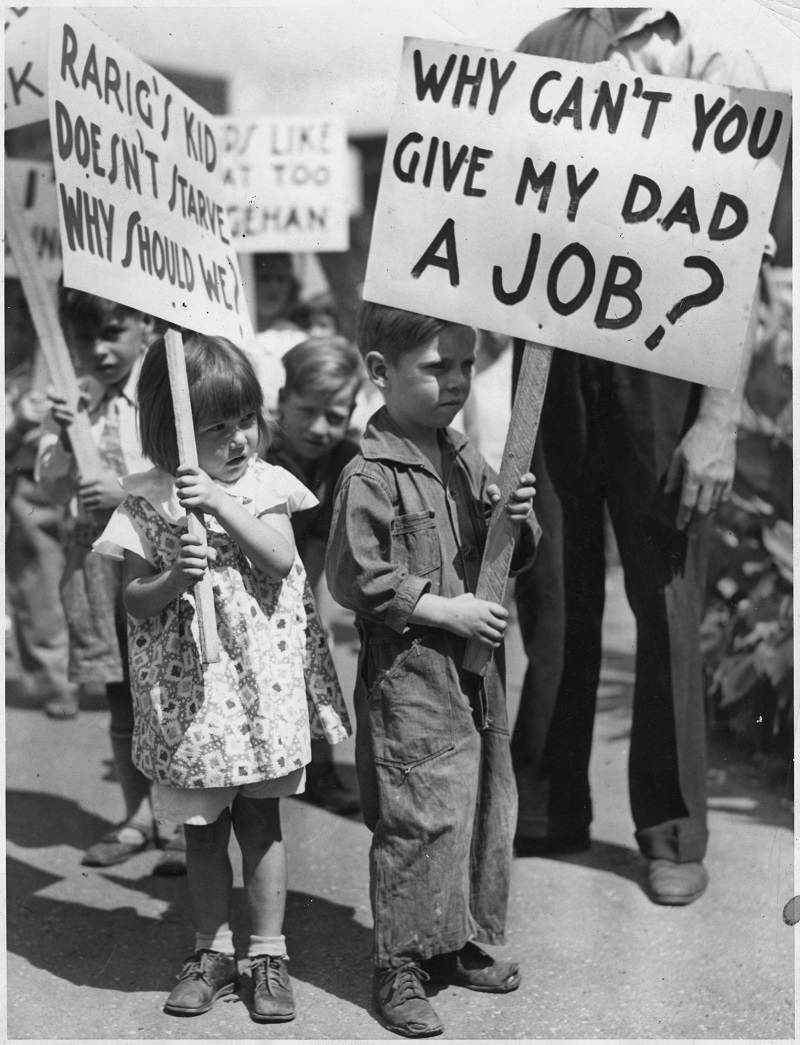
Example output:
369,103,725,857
6,844,372,1011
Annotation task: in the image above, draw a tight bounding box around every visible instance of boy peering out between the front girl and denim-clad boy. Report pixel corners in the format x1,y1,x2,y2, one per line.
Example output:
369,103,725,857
267,336,363,816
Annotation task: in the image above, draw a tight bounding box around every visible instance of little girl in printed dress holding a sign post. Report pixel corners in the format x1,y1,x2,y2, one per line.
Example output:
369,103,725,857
95,334,350,1022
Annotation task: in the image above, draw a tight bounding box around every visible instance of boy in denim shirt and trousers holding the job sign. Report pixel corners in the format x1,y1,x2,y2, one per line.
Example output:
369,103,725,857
326,303,540,1038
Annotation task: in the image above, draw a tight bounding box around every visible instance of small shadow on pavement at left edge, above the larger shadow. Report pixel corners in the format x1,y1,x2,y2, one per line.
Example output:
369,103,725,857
5,790,110,849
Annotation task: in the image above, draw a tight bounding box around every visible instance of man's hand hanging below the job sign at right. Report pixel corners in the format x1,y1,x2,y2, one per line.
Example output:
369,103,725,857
664,417,736,530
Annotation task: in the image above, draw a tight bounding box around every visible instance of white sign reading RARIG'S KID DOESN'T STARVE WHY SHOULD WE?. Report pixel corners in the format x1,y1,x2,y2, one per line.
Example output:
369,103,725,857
48,7,252,345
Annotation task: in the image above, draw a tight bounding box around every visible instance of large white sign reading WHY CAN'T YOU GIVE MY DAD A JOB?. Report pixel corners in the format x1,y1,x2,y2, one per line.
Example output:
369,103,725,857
363,39,791,389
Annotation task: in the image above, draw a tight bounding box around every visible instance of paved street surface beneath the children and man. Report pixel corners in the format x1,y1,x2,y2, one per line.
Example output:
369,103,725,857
6,574,796,1040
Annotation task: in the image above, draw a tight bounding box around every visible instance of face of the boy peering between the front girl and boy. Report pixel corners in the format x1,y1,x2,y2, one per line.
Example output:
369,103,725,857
280,382,355,461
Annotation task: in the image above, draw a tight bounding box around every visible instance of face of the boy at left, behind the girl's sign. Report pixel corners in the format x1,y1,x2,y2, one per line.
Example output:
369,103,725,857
65,311,152,386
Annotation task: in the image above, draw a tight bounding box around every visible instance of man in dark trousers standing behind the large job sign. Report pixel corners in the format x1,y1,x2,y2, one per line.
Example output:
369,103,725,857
513,7,767,905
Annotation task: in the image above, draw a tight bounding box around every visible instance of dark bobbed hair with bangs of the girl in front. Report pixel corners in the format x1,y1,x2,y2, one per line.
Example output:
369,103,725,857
137,333,272,475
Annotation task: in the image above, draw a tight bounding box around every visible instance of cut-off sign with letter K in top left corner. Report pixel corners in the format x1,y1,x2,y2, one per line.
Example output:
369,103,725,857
4,7,49,131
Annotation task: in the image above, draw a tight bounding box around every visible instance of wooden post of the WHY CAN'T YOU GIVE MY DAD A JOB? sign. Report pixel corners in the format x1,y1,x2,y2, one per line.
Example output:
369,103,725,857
464,341,552,675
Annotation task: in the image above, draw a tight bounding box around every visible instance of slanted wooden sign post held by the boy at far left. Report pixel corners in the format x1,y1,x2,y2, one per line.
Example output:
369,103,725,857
4,178,105,482
